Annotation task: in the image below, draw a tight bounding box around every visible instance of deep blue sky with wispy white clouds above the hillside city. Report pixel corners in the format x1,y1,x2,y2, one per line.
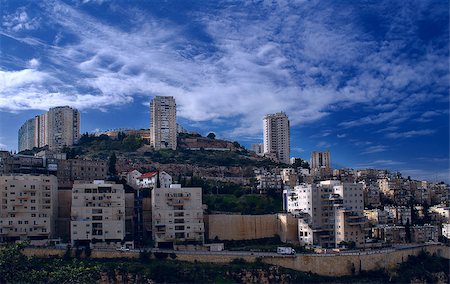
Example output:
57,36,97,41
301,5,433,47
0,0,449,182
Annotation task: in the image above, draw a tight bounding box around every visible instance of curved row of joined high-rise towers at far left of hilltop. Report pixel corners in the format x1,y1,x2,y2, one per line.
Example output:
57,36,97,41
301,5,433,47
18,106,80,151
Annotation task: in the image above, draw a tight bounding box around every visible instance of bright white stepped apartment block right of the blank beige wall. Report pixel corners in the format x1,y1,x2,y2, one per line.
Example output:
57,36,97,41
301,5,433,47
283,180,365,247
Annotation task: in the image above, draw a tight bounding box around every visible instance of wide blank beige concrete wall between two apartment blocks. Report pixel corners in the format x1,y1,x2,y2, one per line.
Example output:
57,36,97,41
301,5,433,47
205,214,278,240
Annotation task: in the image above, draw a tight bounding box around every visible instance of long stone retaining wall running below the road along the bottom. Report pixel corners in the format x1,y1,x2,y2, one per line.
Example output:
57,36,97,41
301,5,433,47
24,245,450,276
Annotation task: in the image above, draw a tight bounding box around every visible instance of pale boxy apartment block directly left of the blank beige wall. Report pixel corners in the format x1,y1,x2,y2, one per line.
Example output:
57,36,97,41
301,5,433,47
151,184,205,248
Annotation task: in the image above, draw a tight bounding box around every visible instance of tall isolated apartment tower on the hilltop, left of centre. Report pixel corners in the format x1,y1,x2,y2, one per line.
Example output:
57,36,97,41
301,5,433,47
150,96,177,150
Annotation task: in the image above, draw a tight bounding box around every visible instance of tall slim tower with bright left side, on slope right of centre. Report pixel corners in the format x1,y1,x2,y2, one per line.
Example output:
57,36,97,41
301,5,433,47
264,112,291,164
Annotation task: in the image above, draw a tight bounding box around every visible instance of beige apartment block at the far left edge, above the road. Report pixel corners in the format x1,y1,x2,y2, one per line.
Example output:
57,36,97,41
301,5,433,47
0,175,58,241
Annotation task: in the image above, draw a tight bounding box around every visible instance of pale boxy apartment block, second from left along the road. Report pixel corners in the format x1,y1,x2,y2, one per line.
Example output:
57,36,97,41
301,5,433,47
70,180,125,246
